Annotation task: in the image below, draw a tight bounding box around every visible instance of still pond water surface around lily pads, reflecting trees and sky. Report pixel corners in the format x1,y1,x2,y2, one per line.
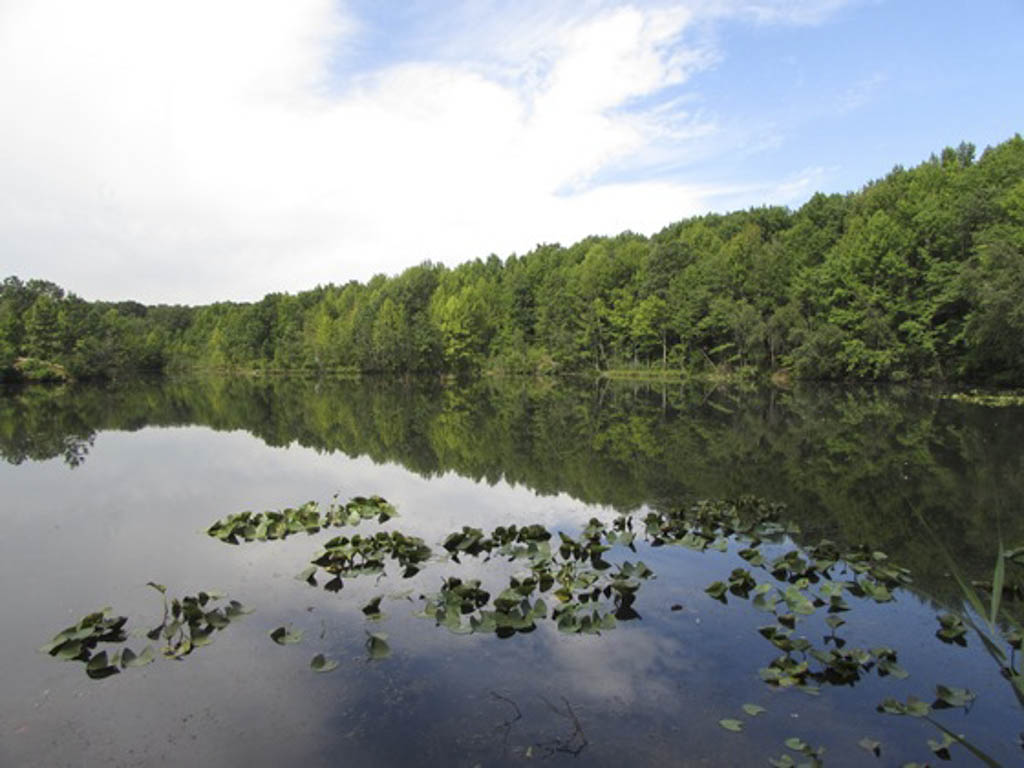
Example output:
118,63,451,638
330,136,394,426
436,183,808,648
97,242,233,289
0,378,1024,766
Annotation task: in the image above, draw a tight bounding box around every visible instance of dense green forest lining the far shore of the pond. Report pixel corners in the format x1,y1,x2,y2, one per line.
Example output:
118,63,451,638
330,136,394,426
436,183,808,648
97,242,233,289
0,134,1024,386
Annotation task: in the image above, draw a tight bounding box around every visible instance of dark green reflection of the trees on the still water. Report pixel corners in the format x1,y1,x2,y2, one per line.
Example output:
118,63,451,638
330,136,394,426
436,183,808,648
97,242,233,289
6,377,1024,600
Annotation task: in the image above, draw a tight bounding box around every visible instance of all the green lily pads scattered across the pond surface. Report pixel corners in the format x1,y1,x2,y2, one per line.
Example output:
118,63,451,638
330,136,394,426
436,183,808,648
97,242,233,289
43,496,1024,768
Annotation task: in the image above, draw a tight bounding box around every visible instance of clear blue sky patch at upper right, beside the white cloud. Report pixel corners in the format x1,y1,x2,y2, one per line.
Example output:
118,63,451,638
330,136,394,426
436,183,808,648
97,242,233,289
693,0,1024,191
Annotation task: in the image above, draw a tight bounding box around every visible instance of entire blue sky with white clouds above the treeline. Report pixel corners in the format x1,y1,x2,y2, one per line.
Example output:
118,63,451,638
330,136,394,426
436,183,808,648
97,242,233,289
0,0,1024,304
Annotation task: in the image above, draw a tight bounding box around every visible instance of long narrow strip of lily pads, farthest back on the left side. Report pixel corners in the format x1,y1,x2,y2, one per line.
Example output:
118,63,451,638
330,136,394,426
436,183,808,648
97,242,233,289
206,496,397,544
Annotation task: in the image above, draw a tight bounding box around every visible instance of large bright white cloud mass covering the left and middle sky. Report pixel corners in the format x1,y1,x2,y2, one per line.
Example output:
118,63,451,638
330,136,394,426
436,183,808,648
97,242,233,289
0,0,847,302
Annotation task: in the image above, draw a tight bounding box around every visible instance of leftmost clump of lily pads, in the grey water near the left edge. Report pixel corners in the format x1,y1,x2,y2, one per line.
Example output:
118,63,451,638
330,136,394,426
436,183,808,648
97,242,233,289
40,582,250,679
